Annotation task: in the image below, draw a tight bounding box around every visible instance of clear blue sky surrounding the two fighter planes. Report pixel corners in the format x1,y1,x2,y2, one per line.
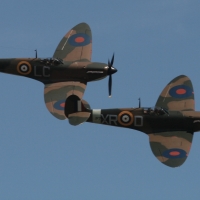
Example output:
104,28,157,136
0,0,200,200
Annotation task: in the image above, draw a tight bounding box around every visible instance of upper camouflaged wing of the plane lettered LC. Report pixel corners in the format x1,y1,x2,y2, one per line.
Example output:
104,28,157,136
53,23,92,61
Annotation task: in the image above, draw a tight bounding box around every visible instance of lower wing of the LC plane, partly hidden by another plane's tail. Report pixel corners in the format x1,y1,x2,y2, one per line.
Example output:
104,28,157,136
44,81,86,120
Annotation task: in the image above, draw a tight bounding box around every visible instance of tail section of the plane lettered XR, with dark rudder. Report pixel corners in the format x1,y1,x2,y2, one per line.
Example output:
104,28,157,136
65,95,91,126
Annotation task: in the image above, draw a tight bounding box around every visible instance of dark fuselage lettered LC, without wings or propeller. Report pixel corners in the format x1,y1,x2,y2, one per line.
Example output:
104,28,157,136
0,58,108,84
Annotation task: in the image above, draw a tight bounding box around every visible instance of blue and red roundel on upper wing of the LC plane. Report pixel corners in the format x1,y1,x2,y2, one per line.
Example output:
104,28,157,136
68,33,91,47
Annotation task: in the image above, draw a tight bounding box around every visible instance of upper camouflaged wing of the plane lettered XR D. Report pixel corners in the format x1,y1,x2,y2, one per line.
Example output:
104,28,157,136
156,75,195,111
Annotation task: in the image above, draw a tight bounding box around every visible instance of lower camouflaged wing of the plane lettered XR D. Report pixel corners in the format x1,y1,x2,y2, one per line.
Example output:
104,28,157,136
149,131,193,167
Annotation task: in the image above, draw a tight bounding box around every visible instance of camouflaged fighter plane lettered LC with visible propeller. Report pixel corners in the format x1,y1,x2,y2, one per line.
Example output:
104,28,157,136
0,23,117,119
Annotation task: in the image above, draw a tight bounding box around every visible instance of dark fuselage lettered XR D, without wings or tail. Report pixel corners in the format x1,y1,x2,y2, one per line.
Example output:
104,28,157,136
87,108,200,134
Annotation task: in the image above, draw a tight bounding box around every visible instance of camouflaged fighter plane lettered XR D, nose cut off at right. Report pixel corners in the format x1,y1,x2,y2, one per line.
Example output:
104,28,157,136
65,75,200,167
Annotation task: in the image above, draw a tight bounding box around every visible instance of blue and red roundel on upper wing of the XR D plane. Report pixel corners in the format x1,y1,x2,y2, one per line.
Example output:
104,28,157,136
169,85,193,99
